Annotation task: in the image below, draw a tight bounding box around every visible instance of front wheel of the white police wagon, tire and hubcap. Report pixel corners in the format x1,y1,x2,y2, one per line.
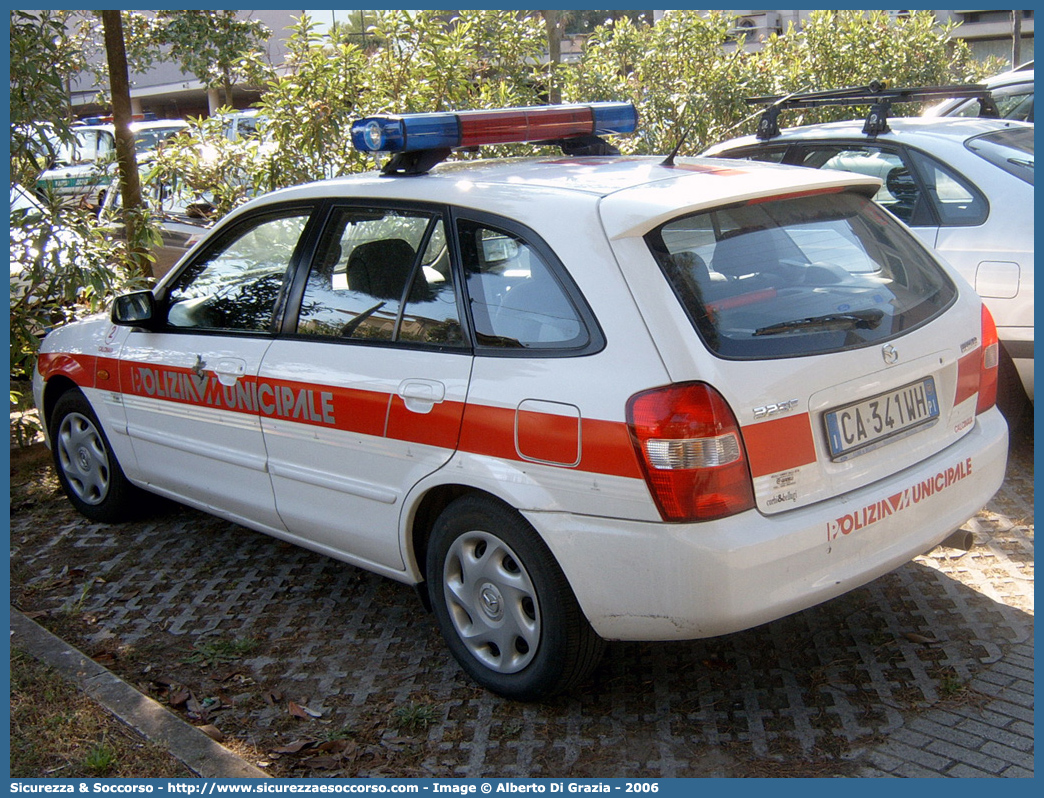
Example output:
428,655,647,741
50,389,144,523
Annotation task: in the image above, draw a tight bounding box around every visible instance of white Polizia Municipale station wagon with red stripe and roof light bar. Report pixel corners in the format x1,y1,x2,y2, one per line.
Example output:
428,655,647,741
34,103,1007,699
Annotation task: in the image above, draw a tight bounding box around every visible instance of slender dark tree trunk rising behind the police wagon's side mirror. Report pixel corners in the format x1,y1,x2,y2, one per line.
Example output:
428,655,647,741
98,10,152,278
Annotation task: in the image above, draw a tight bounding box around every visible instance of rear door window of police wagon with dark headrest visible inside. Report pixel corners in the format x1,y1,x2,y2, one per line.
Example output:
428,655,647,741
298,208,464,346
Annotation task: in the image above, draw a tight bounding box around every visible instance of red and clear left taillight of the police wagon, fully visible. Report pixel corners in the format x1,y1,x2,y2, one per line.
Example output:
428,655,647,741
627,382,754,521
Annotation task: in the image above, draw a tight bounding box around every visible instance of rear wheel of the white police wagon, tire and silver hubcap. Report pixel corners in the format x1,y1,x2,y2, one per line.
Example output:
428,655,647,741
427,494,604,701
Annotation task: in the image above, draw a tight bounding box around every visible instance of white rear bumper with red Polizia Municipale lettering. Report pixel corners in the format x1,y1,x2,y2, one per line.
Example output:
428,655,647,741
527,408,1007,640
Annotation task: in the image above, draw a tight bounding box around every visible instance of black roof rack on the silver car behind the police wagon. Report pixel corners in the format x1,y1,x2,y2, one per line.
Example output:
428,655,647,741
746,80,1000,141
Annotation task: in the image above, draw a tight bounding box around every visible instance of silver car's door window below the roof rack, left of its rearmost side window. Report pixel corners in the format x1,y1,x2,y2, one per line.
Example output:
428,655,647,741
800,146,933,227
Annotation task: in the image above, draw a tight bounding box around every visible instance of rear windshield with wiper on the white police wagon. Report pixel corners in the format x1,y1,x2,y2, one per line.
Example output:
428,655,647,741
646,193,956,359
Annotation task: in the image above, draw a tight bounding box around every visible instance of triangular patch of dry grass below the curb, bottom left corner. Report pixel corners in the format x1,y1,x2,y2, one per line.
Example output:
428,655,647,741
10,649,194,778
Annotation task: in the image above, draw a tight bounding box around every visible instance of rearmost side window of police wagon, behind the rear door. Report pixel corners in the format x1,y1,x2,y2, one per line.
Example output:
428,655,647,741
457,220,590,349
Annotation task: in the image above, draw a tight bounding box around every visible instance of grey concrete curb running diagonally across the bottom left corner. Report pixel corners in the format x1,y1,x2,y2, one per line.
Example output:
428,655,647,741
10,607,270,778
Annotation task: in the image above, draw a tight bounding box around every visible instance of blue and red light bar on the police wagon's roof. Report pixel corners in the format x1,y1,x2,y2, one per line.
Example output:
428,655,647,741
352,102,638,152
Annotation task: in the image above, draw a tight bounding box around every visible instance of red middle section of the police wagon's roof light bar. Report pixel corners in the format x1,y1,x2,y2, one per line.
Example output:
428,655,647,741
457,105,595,147
